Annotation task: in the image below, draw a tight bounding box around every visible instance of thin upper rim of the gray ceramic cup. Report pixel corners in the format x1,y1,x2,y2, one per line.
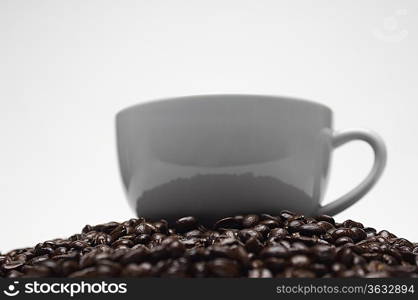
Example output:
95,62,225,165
116,93,332,118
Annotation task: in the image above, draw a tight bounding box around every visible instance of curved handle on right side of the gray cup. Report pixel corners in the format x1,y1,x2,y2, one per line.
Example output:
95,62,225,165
318,129,387,215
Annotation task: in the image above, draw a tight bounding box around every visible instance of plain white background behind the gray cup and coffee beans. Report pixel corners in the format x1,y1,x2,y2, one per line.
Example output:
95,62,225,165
0,0,418,252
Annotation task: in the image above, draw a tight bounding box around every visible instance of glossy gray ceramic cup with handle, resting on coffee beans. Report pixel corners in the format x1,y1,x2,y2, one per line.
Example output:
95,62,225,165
116,95,386,222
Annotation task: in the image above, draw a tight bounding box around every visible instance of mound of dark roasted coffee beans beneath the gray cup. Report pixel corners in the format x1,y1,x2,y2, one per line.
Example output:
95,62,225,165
0,211,418,278
